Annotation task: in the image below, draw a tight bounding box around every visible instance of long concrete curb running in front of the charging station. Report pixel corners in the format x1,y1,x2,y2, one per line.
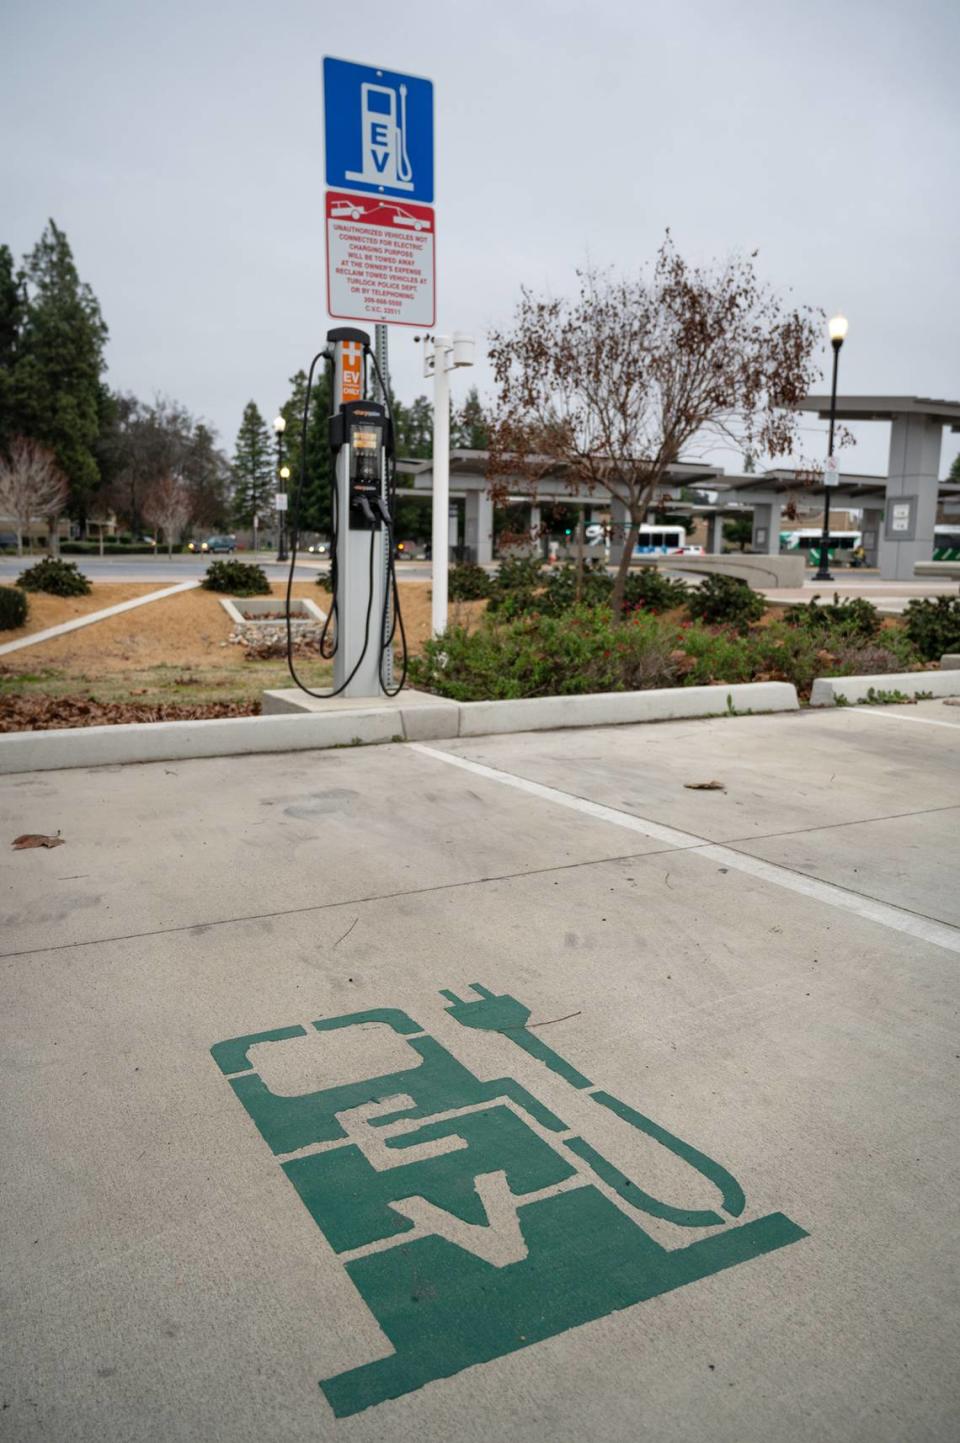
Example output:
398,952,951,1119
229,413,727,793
0,678,796,775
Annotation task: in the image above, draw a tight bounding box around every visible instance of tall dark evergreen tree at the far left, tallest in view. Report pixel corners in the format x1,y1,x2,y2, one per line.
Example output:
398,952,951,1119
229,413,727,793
9,221,107,519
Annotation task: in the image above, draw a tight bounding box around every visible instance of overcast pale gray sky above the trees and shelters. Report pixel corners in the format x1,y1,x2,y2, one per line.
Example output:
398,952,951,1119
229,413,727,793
0,0,960,472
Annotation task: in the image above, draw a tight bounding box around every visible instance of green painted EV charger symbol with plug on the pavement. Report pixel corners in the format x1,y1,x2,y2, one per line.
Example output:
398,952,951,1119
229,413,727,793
211,983,807,1417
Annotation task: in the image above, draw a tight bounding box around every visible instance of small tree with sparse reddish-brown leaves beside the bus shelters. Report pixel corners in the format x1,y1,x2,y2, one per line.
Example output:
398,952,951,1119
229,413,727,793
488,234,820,615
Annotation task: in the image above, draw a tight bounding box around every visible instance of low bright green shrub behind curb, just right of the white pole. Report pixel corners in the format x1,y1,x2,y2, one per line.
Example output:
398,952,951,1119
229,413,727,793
410,606,683,701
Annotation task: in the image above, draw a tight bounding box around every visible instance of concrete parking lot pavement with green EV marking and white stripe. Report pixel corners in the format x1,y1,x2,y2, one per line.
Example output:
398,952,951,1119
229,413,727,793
0,701,960,1443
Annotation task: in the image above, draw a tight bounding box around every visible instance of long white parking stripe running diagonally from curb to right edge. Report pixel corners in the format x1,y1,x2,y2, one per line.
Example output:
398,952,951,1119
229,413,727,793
409,744,960,952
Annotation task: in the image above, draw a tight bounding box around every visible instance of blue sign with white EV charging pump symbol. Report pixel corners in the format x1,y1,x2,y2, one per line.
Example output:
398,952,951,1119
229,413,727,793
323,56,433,205
